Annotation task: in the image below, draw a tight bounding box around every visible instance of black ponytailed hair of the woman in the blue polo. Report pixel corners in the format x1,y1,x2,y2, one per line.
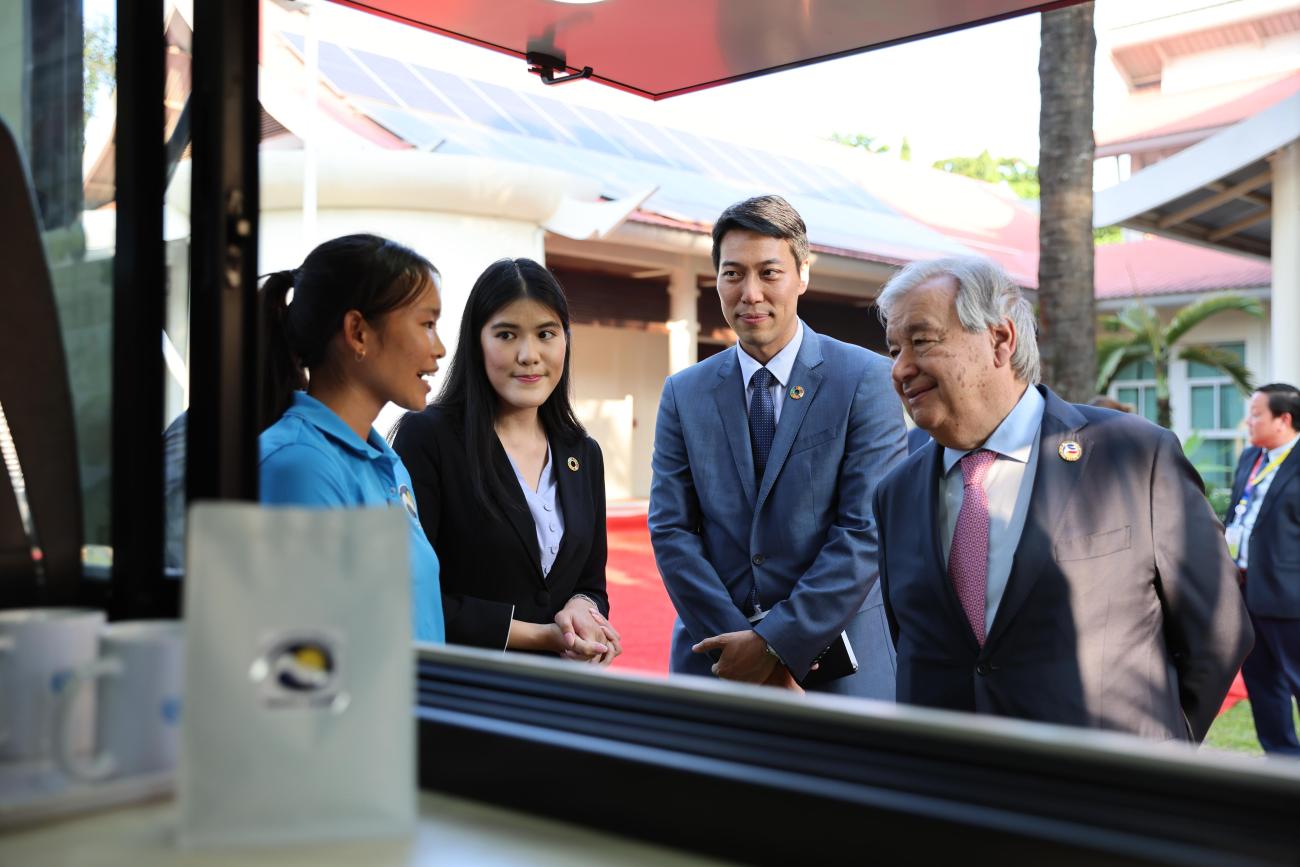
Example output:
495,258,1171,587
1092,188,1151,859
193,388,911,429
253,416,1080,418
257,235,438,430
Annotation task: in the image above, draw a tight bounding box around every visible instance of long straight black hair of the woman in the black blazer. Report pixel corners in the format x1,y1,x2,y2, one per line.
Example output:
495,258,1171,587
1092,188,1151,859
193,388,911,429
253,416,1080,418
434,259,586,513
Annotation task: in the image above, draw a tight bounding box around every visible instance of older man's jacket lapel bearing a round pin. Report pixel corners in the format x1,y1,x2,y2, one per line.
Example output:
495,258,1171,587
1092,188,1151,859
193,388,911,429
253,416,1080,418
985,386,1092,646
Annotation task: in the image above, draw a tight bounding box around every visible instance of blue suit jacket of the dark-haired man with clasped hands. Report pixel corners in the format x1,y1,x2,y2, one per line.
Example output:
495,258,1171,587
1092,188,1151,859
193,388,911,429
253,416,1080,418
650,325,906,699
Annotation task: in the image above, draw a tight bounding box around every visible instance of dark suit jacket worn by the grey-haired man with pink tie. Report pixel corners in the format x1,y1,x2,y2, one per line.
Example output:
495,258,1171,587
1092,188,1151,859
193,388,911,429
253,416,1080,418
874,386,1253,741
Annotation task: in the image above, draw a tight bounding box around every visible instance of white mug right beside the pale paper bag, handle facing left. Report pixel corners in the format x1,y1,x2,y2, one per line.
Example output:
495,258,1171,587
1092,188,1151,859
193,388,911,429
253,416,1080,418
55,620,185,780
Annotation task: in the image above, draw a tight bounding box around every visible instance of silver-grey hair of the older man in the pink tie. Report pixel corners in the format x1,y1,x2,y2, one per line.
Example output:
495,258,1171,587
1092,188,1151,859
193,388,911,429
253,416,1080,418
876,256,1041,385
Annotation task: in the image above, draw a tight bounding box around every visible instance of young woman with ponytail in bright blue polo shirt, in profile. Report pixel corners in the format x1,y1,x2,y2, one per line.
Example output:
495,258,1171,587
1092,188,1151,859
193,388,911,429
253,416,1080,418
257,235,446,642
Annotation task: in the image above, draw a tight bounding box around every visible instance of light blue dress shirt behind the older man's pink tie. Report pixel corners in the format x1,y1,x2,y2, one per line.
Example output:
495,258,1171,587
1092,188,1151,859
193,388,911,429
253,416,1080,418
939,386,1047,630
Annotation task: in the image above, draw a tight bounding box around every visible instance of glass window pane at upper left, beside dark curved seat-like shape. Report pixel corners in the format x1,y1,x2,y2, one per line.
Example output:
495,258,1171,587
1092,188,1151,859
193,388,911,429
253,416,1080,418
0,0,117,564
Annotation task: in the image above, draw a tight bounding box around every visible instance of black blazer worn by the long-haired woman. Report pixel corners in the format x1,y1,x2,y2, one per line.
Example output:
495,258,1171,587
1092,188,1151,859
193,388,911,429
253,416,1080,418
393,406,610,649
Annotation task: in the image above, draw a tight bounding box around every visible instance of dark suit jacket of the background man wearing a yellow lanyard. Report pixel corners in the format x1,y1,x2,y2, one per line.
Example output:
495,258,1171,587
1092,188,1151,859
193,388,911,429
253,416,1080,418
1223,446,1300,620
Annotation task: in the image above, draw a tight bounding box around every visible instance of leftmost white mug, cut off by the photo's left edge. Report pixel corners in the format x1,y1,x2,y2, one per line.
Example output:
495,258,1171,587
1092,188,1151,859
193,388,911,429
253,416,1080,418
0,608,104,762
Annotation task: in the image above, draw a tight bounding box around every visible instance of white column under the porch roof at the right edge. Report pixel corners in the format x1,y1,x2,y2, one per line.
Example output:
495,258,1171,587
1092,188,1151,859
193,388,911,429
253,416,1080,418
1269,142,1300,385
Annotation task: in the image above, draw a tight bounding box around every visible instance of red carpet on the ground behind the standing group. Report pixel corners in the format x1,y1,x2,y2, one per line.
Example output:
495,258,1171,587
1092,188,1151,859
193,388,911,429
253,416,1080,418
606,503,1247,714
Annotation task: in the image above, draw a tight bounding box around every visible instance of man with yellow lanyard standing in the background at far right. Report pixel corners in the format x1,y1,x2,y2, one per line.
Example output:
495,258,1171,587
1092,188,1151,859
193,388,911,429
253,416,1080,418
1226,382,1300,757
